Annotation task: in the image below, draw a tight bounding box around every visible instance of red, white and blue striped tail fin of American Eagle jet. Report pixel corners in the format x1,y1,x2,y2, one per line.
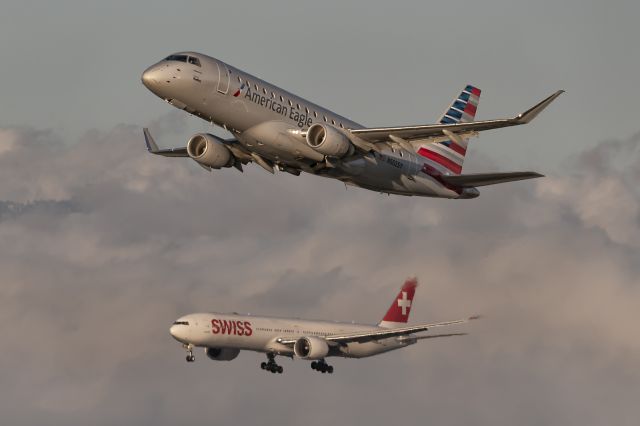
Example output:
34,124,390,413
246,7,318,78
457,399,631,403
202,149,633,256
418,85,480,175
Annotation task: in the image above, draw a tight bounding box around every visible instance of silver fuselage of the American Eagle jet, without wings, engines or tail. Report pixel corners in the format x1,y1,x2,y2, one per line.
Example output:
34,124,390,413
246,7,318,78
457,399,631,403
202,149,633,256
142,52,478,198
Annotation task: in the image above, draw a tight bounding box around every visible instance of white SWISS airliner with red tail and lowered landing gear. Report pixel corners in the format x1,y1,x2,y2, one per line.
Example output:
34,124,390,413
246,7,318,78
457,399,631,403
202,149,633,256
169,278,478,373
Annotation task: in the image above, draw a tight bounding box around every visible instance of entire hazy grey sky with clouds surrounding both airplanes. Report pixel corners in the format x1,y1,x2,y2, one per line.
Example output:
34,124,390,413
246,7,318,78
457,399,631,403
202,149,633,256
0,0,640,426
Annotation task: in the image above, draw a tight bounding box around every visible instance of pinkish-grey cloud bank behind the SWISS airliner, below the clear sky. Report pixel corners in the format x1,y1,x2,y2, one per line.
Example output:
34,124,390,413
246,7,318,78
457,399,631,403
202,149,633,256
0,123,640,425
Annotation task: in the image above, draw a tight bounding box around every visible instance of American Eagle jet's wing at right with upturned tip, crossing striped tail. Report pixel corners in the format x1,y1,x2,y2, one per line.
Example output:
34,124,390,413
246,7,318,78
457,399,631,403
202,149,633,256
350,90,564,143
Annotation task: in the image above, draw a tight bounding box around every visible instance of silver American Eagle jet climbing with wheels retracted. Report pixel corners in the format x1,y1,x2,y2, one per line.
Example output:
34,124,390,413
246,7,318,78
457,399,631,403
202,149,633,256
142,52,563,198
